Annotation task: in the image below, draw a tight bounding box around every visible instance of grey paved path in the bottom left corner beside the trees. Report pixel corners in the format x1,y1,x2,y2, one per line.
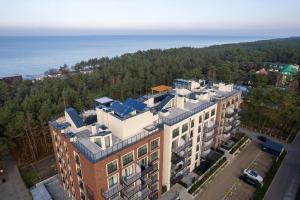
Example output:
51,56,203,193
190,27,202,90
0,156,32,200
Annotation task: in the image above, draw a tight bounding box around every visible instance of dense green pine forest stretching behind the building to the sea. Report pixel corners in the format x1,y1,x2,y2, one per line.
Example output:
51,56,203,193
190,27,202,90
0,38,300,164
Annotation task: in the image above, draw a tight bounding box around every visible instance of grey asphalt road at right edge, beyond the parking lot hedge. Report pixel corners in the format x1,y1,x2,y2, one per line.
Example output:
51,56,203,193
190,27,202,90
240,128,300,200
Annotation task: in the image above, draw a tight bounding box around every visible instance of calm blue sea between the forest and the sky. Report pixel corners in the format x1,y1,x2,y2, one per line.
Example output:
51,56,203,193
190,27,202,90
0,35,272,77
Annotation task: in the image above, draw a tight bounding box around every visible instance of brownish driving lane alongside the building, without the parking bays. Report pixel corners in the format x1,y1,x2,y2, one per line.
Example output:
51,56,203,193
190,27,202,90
195,141,261,200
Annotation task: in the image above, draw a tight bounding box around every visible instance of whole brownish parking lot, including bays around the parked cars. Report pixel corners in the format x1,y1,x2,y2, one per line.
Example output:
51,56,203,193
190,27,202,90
195,141,274,200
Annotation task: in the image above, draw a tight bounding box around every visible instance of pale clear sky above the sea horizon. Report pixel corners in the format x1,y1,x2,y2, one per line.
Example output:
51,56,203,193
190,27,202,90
0,0,300,36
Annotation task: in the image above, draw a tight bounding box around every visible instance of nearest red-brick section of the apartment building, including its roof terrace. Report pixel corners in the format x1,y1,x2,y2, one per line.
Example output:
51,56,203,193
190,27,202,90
49,98,163,200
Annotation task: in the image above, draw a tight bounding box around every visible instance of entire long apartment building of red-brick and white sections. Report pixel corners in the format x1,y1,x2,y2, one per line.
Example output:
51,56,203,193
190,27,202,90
49,79,241,199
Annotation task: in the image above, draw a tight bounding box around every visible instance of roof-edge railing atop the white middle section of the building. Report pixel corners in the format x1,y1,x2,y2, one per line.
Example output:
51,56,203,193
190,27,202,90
161,101,216,126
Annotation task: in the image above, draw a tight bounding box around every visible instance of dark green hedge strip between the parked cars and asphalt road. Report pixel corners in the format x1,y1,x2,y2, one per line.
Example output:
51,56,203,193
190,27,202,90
253,151,286,200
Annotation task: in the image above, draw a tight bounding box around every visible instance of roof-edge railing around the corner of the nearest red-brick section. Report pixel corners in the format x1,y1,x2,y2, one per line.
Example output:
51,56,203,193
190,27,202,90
74,127,159,163
